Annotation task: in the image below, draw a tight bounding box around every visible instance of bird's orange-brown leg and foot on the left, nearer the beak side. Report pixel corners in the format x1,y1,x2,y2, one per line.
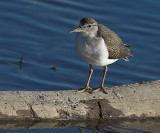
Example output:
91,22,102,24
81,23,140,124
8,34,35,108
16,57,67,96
79,64,93,93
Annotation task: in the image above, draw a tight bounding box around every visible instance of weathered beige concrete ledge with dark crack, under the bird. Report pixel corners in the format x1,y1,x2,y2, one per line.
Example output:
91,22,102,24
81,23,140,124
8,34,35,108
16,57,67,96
0,80,160,120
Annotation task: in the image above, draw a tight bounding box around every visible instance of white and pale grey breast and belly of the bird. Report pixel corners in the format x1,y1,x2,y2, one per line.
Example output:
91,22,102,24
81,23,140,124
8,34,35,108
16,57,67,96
76,33,117,66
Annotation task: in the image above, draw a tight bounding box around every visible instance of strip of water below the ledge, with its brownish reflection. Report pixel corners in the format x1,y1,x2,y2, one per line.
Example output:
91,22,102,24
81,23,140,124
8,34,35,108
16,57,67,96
0,119,160,133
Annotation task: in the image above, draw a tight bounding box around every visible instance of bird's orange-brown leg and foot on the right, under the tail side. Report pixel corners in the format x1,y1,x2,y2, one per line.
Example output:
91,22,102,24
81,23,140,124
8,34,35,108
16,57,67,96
93,66,107,94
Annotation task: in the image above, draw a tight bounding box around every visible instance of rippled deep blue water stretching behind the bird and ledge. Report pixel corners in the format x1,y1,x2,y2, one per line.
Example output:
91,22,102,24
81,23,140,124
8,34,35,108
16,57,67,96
0,0,160,132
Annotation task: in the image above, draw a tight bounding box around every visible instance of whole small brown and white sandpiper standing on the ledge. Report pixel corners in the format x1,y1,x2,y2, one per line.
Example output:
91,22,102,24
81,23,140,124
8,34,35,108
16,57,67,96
69,17,133,93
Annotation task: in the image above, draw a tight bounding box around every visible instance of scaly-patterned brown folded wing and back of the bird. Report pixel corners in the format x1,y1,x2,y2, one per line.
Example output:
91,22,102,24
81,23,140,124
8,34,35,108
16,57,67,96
97,24,133,59
